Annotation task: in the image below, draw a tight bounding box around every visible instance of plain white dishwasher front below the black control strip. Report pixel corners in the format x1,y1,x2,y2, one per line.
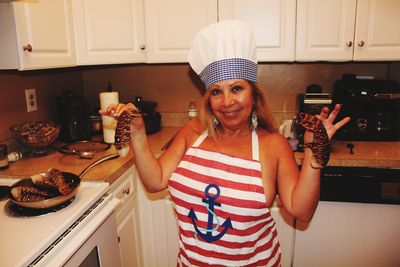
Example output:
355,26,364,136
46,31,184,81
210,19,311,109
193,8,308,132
293,201,400,267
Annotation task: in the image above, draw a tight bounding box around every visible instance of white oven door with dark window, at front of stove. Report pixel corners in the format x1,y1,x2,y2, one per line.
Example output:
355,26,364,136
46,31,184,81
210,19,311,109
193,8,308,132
30,194,122,267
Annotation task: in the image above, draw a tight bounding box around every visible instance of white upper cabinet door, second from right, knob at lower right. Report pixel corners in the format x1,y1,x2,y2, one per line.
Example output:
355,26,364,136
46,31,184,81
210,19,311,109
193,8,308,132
296,0,356,61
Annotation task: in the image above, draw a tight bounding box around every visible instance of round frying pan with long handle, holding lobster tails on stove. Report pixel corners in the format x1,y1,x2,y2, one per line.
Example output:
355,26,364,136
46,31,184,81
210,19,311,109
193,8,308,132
1,153,119,209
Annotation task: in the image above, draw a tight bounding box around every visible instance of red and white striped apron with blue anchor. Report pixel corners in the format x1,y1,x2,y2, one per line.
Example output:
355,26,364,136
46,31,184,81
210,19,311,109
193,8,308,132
168,131,281,266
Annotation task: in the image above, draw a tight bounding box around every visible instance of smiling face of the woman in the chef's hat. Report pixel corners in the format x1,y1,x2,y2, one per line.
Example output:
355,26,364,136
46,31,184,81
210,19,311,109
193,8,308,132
207,79,253,130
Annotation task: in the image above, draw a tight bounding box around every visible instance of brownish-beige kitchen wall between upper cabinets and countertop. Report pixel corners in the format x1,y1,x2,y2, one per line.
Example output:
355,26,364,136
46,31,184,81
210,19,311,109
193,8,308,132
0,63,389,140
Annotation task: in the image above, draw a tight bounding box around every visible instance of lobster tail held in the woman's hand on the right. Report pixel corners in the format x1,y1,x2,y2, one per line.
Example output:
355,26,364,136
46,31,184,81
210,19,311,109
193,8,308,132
294,113,332,168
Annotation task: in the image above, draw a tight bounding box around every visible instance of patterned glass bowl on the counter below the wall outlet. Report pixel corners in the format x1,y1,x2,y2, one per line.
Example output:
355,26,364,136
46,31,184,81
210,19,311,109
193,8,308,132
10,121,60,157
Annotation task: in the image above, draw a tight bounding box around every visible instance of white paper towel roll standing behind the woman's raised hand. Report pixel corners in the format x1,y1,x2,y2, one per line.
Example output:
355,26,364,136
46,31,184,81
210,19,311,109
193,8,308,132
100,92,119,144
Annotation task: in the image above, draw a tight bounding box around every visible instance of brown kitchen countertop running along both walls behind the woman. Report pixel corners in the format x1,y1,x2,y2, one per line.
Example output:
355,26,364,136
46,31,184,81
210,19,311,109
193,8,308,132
0,127,400,183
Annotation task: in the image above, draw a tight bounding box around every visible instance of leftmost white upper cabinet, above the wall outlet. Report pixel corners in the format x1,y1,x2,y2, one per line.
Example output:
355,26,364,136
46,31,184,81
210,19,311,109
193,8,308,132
0,0,75,70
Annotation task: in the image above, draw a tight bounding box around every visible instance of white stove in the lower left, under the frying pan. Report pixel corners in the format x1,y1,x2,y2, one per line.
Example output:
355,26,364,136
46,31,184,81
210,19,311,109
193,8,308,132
0,179,119,267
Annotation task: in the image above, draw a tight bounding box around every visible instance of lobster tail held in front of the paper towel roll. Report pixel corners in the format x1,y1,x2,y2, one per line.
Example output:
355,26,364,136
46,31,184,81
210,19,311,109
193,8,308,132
114,110,141,157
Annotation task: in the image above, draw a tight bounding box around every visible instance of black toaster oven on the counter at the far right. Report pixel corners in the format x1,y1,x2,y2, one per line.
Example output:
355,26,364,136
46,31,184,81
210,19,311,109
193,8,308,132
332,75,400,141
